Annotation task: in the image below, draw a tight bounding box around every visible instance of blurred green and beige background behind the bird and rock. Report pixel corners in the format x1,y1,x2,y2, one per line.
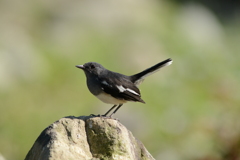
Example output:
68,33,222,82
0,0,240,160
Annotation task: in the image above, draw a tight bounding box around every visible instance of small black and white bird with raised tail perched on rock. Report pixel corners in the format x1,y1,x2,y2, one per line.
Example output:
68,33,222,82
76,58,173,118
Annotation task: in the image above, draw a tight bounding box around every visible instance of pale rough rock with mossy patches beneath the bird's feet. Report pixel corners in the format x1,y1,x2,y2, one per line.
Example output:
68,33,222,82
25,116,154,160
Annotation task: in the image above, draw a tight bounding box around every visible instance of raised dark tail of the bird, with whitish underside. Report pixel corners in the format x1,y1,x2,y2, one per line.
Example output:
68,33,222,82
130,58,172,85
